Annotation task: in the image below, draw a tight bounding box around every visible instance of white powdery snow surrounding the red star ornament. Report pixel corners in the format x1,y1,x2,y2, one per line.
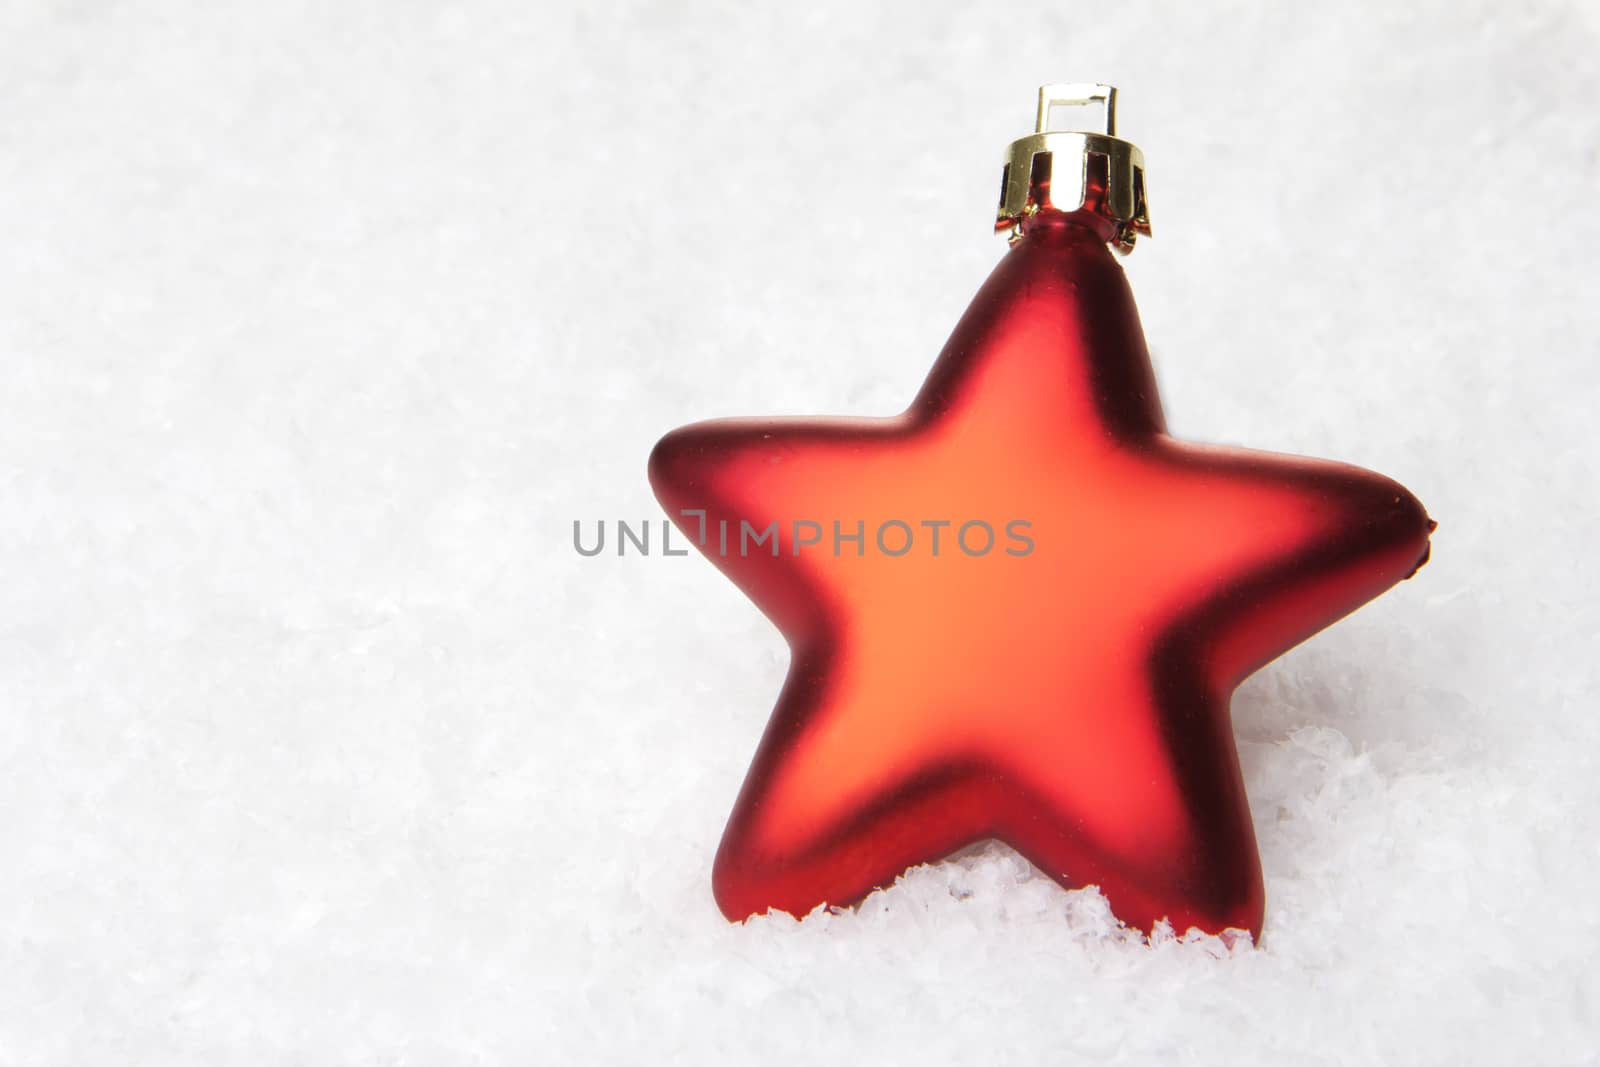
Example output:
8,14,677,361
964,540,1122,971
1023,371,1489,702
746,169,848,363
0,0,1600,1067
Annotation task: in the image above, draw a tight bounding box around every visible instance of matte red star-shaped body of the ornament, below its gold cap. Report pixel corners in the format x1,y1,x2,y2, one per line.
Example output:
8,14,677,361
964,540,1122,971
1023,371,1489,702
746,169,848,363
650,211,1432,936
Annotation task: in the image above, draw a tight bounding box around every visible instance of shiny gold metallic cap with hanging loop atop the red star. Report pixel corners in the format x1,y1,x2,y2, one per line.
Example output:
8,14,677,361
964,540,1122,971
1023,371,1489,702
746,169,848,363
995,82,1150,254
